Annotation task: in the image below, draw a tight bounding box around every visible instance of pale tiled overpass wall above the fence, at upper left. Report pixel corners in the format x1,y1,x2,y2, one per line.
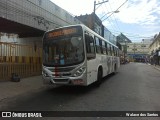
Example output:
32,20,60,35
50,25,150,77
0,0,80,31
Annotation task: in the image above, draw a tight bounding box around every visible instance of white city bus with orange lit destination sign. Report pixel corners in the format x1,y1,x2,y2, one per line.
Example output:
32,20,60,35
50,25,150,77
42,25,120,86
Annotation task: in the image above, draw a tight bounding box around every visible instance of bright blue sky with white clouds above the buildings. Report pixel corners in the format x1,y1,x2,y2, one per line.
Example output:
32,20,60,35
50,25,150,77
51,0,160,42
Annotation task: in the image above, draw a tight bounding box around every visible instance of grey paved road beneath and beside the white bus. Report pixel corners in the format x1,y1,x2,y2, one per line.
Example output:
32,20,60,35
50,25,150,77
0,63,160,120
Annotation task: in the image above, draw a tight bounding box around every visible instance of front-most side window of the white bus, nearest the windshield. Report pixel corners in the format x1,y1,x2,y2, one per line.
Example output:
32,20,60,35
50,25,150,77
85,34,95,59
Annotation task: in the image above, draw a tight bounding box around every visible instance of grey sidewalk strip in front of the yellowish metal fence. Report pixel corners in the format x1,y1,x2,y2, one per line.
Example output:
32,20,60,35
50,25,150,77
0,76,45,101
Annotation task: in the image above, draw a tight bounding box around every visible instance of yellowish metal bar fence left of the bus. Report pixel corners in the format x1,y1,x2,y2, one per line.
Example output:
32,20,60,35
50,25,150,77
0,42,42,80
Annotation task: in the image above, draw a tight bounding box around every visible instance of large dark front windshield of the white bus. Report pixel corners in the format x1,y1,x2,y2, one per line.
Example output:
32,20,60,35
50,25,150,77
43,35,84,67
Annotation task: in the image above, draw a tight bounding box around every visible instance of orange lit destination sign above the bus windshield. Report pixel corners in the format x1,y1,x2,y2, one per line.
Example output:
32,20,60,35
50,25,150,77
48,28,77,38
